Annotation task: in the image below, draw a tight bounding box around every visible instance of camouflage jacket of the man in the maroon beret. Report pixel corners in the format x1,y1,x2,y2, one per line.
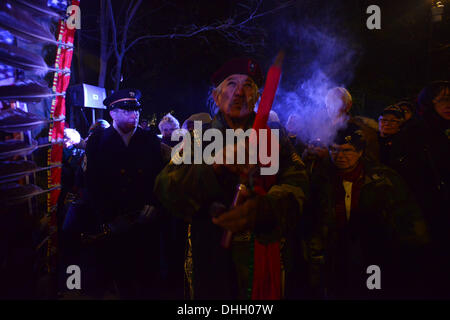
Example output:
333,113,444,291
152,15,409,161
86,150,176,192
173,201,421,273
155,113,308,299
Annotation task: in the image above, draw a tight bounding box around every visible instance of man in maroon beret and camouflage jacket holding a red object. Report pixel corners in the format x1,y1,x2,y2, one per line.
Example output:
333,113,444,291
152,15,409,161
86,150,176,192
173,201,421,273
155,58,307,299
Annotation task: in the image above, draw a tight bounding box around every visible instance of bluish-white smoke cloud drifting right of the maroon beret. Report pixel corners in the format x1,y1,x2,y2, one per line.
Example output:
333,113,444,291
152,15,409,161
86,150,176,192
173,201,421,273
273,25,358,144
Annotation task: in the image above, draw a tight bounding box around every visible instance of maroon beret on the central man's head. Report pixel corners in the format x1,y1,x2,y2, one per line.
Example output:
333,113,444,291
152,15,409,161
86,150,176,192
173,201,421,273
211,58,264,88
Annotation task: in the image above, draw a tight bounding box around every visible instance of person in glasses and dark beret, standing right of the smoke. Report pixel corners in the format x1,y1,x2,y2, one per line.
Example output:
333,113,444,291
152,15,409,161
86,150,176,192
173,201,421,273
307,124,429,299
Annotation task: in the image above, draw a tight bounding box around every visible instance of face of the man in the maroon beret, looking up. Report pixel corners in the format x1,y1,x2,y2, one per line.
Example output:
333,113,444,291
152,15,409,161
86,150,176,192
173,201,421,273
213,74,259,118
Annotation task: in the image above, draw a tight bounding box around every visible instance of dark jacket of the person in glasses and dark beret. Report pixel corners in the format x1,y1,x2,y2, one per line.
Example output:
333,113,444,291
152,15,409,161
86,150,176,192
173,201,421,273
309,163,429,298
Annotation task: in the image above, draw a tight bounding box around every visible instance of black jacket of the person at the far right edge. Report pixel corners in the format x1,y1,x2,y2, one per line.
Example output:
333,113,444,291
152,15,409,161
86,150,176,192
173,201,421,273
390,112,450,243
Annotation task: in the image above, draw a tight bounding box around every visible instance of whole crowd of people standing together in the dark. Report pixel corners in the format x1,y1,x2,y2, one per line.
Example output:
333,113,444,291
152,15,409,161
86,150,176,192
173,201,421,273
54,58,450,300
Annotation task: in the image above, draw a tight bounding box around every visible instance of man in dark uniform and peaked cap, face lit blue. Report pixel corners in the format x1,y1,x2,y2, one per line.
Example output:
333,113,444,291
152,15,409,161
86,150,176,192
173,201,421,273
82,89,163,299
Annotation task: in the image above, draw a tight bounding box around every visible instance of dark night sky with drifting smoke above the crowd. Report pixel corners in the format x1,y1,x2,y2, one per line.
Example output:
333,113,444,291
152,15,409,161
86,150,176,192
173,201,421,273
67,0,450,133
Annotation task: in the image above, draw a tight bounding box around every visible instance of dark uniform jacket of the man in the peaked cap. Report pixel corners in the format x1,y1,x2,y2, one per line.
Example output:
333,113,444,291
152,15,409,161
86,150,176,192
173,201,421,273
86,126,163,223
